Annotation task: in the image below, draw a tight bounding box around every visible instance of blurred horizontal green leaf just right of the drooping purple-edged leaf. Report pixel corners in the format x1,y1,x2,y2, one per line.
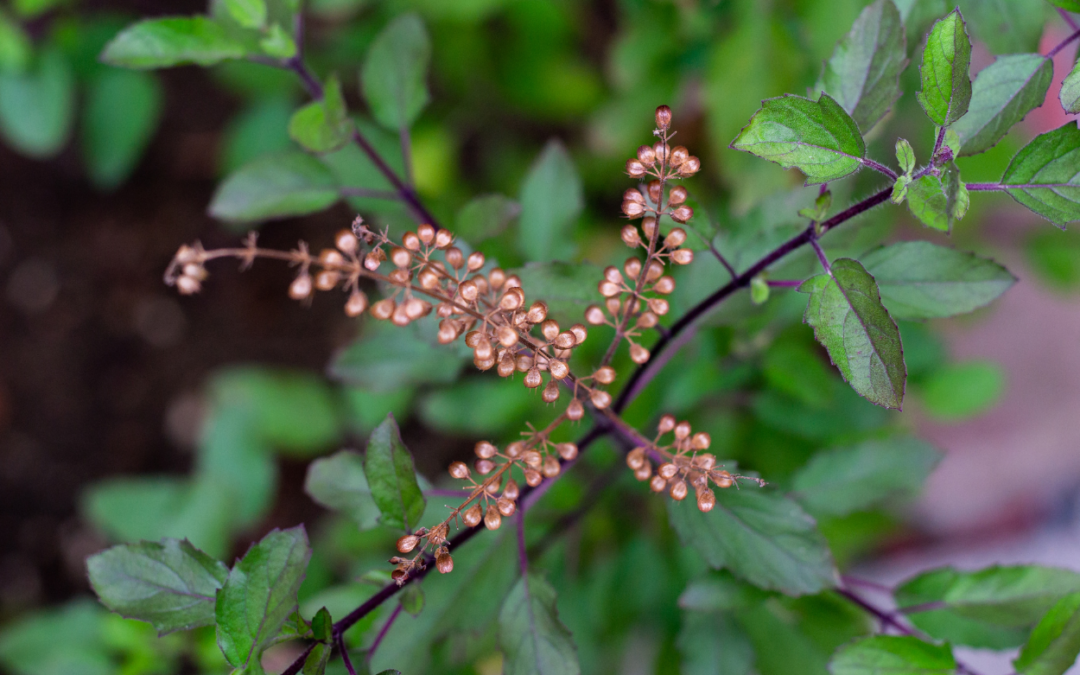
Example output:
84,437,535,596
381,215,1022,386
862,242,1016,319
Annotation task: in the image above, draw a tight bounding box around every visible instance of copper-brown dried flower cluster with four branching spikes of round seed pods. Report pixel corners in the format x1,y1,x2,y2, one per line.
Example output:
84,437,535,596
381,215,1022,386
165,106,764,583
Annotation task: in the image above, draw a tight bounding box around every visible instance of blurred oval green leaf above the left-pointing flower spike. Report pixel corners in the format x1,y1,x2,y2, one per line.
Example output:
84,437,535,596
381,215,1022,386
210,152,338,227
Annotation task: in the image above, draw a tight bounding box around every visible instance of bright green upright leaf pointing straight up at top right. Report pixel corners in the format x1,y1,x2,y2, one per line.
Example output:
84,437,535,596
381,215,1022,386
916,10,971,126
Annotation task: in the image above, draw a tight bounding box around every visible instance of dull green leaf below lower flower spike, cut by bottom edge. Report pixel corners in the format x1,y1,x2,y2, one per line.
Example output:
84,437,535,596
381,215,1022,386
499,575,581,675
